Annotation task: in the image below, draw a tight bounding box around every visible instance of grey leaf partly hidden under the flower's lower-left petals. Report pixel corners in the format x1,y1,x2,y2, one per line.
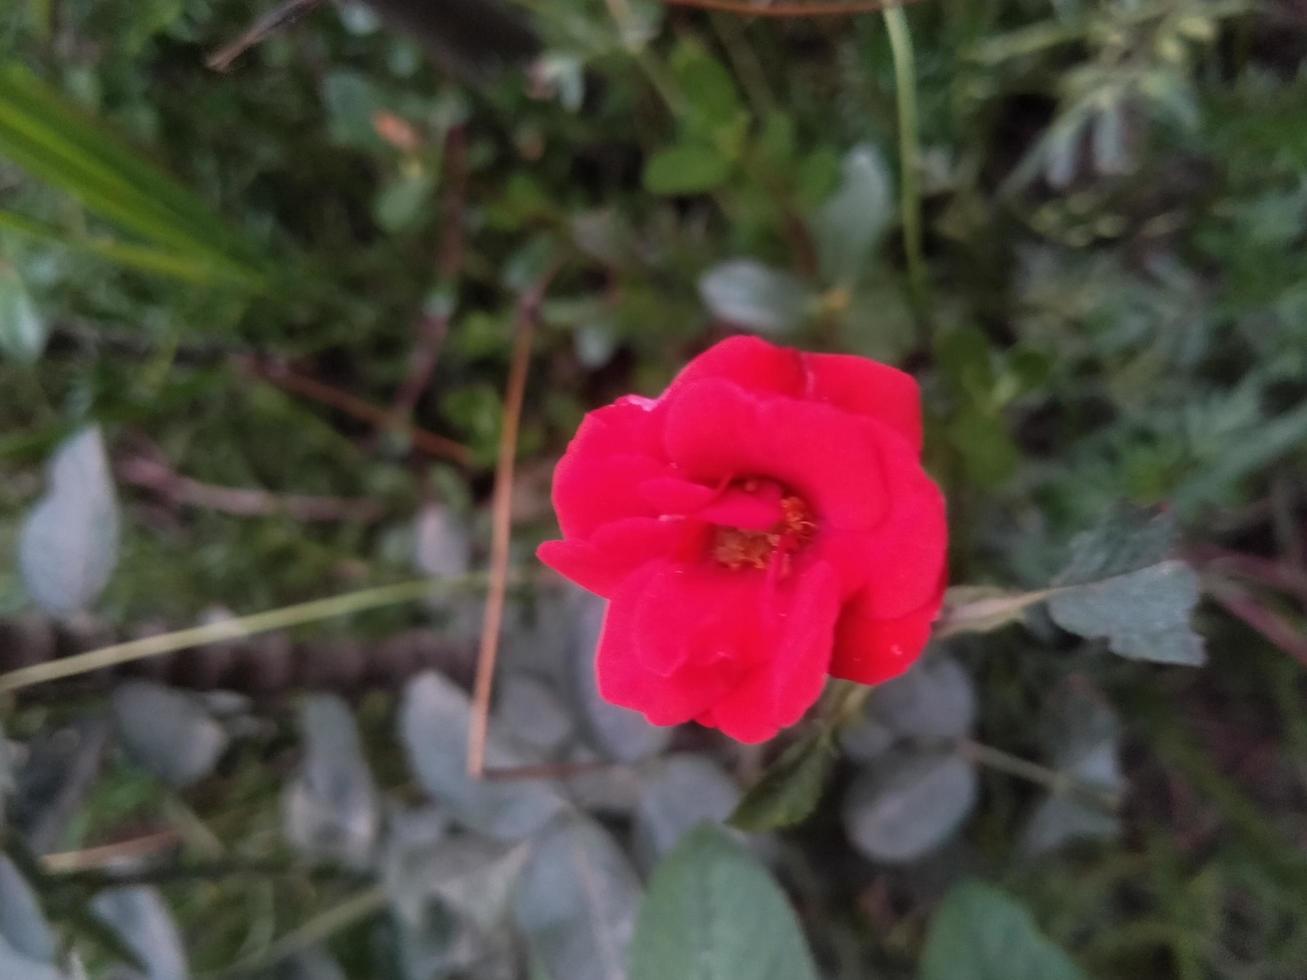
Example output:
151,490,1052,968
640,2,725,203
565,591,672,762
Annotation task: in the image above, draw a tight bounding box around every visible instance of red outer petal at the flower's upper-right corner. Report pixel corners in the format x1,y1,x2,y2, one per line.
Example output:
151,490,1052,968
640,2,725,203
802,354,921,453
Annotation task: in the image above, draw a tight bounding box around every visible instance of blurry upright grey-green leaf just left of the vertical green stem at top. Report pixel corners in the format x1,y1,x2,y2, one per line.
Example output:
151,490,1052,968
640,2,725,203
813,144,894,289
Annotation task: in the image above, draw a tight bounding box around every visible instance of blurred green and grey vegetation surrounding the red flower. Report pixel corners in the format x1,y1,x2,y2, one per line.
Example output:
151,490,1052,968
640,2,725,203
0,0,1307,980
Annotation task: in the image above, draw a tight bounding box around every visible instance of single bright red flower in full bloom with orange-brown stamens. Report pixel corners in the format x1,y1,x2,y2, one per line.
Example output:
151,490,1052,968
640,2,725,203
540,337,948,742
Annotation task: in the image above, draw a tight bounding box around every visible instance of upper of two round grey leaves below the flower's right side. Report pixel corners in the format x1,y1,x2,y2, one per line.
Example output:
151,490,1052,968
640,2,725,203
870,653,976,738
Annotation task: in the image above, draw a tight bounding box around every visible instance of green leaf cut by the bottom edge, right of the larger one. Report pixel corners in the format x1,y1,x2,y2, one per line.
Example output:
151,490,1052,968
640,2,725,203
921,882,1085,980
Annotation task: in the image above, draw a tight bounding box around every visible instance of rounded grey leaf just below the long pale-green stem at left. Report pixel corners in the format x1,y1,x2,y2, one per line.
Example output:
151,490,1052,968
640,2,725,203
110,681,227,787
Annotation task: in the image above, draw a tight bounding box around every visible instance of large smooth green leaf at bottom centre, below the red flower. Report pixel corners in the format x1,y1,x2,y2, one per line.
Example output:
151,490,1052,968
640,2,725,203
630,827,817,980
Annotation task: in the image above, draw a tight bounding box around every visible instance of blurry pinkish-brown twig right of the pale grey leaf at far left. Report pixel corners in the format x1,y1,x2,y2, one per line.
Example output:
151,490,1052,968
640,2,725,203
116,453,384,523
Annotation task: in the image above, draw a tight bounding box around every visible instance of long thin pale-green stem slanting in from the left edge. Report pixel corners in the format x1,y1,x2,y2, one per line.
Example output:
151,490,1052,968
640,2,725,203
0,574,485,694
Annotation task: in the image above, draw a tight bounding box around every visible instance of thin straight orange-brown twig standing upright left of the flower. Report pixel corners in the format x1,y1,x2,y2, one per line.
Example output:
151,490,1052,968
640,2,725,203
468,267,557,779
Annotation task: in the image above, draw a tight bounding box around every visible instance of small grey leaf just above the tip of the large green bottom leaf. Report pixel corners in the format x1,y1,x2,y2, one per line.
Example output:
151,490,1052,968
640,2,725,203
633,754,740,868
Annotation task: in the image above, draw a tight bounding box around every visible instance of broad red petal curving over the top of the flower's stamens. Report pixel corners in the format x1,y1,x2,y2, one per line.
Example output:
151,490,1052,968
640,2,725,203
664,380,886,531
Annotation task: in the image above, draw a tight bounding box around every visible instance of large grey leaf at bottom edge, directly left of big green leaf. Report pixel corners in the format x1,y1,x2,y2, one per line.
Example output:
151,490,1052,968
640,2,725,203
514,815,640,980
